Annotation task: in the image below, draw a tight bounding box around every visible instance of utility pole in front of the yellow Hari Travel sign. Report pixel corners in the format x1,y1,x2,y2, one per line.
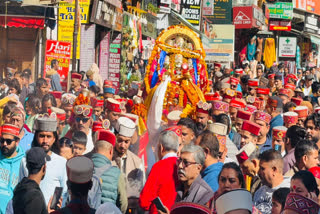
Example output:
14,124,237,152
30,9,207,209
67,0,80,91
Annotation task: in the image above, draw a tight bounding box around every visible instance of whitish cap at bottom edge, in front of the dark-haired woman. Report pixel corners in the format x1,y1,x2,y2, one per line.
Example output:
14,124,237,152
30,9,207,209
216,189,253,214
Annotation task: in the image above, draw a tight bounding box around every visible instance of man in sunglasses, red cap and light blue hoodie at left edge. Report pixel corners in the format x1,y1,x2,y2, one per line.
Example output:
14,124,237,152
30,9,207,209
0,124,25,213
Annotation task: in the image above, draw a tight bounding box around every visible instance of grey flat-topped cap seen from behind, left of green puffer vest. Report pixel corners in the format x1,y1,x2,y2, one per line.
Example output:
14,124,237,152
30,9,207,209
67,156,94,184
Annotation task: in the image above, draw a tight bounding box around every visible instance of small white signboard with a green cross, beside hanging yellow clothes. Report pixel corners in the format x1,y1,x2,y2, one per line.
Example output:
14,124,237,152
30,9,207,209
278,37,297,58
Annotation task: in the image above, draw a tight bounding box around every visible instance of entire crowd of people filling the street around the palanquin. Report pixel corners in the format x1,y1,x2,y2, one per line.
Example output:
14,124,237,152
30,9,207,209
0,62,320,214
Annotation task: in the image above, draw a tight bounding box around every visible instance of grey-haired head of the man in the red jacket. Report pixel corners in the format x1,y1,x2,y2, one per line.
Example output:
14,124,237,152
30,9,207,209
158,131,179,160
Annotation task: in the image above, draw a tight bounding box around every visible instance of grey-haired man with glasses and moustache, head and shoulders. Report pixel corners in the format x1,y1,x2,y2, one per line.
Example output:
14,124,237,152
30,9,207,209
176,144,213,205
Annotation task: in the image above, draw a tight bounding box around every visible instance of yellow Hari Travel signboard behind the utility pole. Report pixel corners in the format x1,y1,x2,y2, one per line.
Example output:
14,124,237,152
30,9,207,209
58,0,90,59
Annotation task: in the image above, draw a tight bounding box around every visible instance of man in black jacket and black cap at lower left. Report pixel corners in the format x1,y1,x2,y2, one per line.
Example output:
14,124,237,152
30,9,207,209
12,147,49,214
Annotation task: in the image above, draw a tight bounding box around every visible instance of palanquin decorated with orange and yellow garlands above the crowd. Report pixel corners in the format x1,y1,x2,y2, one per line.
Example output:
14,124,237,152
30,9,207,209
144,25,209,121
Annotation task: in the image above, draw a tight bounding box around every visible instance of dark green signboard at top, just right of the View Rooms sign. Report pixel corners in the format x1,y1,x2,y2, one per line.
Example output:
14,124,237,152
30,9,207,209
204,0,232,24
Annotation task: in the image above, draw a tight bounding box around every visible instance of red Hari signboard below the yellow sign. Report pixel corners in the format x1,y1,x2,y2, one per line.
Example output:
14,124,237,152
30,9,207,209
43,40,72,90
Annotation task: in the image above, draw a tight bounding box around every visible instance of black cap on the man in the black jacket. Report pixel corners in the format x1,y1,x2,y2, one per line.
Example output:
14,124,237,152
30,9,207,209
26,147,50,174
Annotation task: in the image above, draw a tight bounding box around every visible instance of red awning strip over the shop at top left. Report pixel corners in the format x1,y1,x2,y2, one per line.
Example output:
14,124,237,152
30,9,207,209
0,16,44,29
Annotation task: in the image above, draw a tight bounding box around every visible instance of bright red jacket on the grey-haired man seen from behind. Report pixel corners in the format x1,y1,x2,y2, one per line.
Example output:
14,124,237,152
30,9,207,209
139,157,178,214
